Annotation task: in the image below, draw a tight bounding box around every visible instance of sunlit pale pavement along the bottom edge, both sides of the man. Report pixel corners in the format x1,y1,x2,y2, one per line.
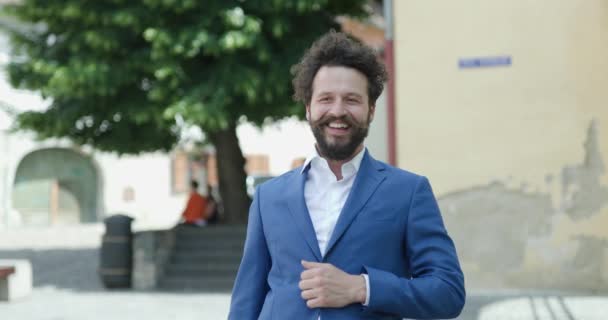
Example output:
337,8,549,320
0,287,608,320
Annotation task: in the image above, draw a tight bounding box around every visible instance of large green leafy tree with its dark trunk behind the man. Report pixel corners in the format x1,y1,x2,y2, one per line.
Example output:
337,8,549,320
3,0,366,222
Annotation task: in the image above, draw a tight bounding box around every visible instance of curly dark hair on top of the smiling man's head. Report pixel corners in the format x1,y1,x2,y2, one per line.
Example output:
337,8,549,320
291,30,388,105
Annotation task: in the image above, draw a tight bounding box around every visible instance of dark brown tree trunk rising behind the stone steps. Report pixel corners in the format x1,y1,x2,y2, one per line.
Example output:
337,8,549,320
209,126,250,224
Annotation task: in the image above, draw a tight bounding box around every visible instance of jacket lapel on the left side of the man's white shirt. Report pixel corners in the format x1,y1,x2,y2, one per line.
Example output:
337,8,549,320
285,171,322,261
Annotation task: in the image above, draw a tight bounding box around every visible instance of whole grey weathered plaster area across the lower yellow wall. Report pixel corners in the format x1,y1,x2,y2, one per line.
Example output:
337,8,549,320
439,121,608,291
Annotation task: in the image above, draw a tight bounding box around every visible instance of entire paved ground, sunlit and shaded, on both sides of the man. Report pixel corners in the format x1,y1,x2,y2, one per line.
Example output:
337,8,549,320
0,226,608,320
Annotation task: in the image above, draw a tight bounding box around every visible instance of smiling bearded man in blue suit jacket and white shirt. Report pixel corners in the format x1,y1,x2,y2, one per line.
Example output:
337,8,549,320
229,31,465,320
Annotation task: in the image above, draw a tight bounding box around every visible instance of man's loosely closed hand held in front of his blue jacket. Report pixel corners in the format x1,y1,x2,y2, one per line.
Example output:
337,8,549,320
300,261,367,308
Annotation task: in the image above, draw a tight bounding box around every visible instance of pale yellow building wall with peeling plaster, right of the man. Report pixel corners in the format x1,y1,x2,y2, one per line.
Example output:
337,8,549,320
393,0,608,290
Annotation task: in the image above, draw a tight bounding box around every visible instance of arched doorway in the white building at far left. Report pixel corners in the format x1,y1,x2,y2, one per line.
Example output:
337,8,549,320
12,148,99,225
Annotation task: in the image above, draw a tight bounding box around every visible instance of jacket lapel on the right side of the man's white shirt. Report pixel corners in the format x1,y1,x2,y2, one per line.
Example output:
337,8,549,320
325,150,386,257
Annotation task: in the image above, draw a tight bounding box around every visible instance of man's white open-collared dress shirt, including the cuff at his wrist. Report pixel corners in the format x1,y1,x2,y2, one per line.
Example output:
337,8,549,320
301,148,370,306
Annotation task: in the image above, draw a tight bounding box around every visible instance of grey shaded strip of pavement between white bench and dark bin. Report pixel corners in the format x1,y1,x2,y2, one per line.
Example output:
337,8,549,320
0,248,105,291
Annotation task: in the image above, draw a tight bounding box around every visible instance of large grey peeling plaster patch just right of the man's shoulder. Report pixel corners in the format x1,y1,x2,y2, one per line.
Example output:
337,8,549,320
439,182,554,271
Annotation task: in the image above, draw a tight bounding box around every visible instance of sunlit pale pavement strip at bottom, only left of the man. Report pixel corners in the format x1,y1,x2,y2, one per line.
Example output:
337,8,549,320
0,287,230,320
